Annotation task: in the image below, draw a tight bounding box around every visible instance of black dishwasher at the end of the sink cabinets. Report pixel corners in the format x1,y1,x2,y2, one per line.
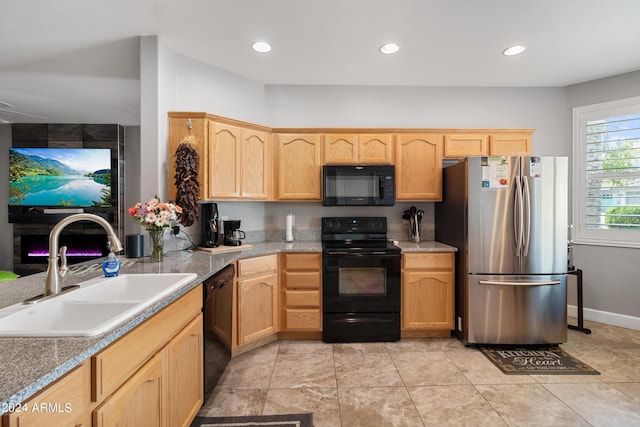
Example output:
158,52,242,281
203,264,235,402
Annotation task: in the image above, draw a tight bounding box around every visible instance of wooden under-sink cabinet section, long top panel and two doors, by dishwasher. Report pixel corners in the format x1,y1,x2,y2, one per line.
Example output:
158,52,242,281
91,286,204,427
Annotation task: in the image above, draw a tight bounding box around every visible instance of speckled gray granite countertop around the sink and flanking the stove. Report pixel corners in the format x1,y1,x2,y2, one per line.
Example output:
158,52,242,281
0,241,457,415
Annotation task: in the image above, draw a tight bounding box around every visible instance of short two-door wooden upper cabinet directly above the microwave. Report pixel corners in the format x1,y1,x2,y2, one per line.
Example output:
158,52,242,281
324,133,393,164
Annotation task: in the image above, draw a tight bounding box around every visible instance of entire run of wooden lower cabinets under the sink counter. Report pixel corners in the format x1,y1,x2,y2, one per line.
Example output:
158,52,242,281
3,286,204,427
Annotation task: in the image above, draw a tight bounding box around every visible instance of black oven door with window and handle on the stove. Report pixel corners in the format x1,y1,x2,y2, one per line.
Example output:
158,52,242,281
322,250,400,313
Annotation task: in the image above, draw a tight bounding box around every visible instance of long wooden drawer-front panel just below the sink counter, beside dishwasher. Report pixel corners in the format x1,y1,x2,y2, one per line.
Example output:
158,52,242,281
91,286,202,402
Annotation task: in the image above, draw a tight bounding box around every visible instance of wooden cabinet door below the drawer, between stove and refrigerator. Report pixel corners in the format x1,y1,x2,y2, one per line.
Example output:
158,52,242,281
402,271,454,330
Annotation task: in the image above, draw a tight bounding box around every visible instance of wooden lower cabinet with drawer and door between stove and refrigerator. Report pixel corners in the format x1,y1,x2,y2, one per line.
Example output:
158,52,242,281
401,252,454,336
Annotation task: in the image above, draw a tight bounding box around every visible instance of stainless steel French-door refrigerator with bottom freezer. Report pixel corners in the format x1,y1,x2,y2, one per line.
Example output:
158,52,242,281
435,157,568,344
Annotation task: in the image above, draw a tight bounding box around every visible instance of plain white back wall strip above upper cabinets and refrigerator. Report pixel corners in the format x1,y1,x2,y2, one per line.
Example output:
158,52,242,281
267,86,570,156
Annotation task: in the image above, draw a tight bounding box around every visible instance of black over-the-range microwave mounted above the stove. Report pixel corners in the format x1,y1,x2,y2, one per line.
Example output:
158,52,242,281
322,165,396,206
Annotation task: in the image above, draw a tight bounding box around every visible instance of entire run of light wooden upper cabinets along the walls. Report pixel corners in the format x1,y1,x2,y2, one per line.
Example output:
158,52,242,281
169,112,534,201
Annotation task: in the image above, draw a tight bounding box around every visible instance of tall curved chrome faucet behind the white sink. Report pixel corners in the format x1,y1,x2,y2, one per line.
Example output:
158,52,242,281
44,213,122,297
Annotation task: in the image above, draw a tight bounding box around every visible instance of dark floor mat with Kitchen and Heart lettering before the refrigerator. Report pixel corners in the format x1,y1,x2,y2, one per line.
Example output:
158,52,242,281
480,346,600,375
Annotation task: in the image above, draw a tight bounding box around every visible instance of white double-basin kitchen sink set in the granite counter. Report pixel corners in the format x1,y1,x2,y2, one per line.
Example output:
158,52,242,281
0,273,197,337
